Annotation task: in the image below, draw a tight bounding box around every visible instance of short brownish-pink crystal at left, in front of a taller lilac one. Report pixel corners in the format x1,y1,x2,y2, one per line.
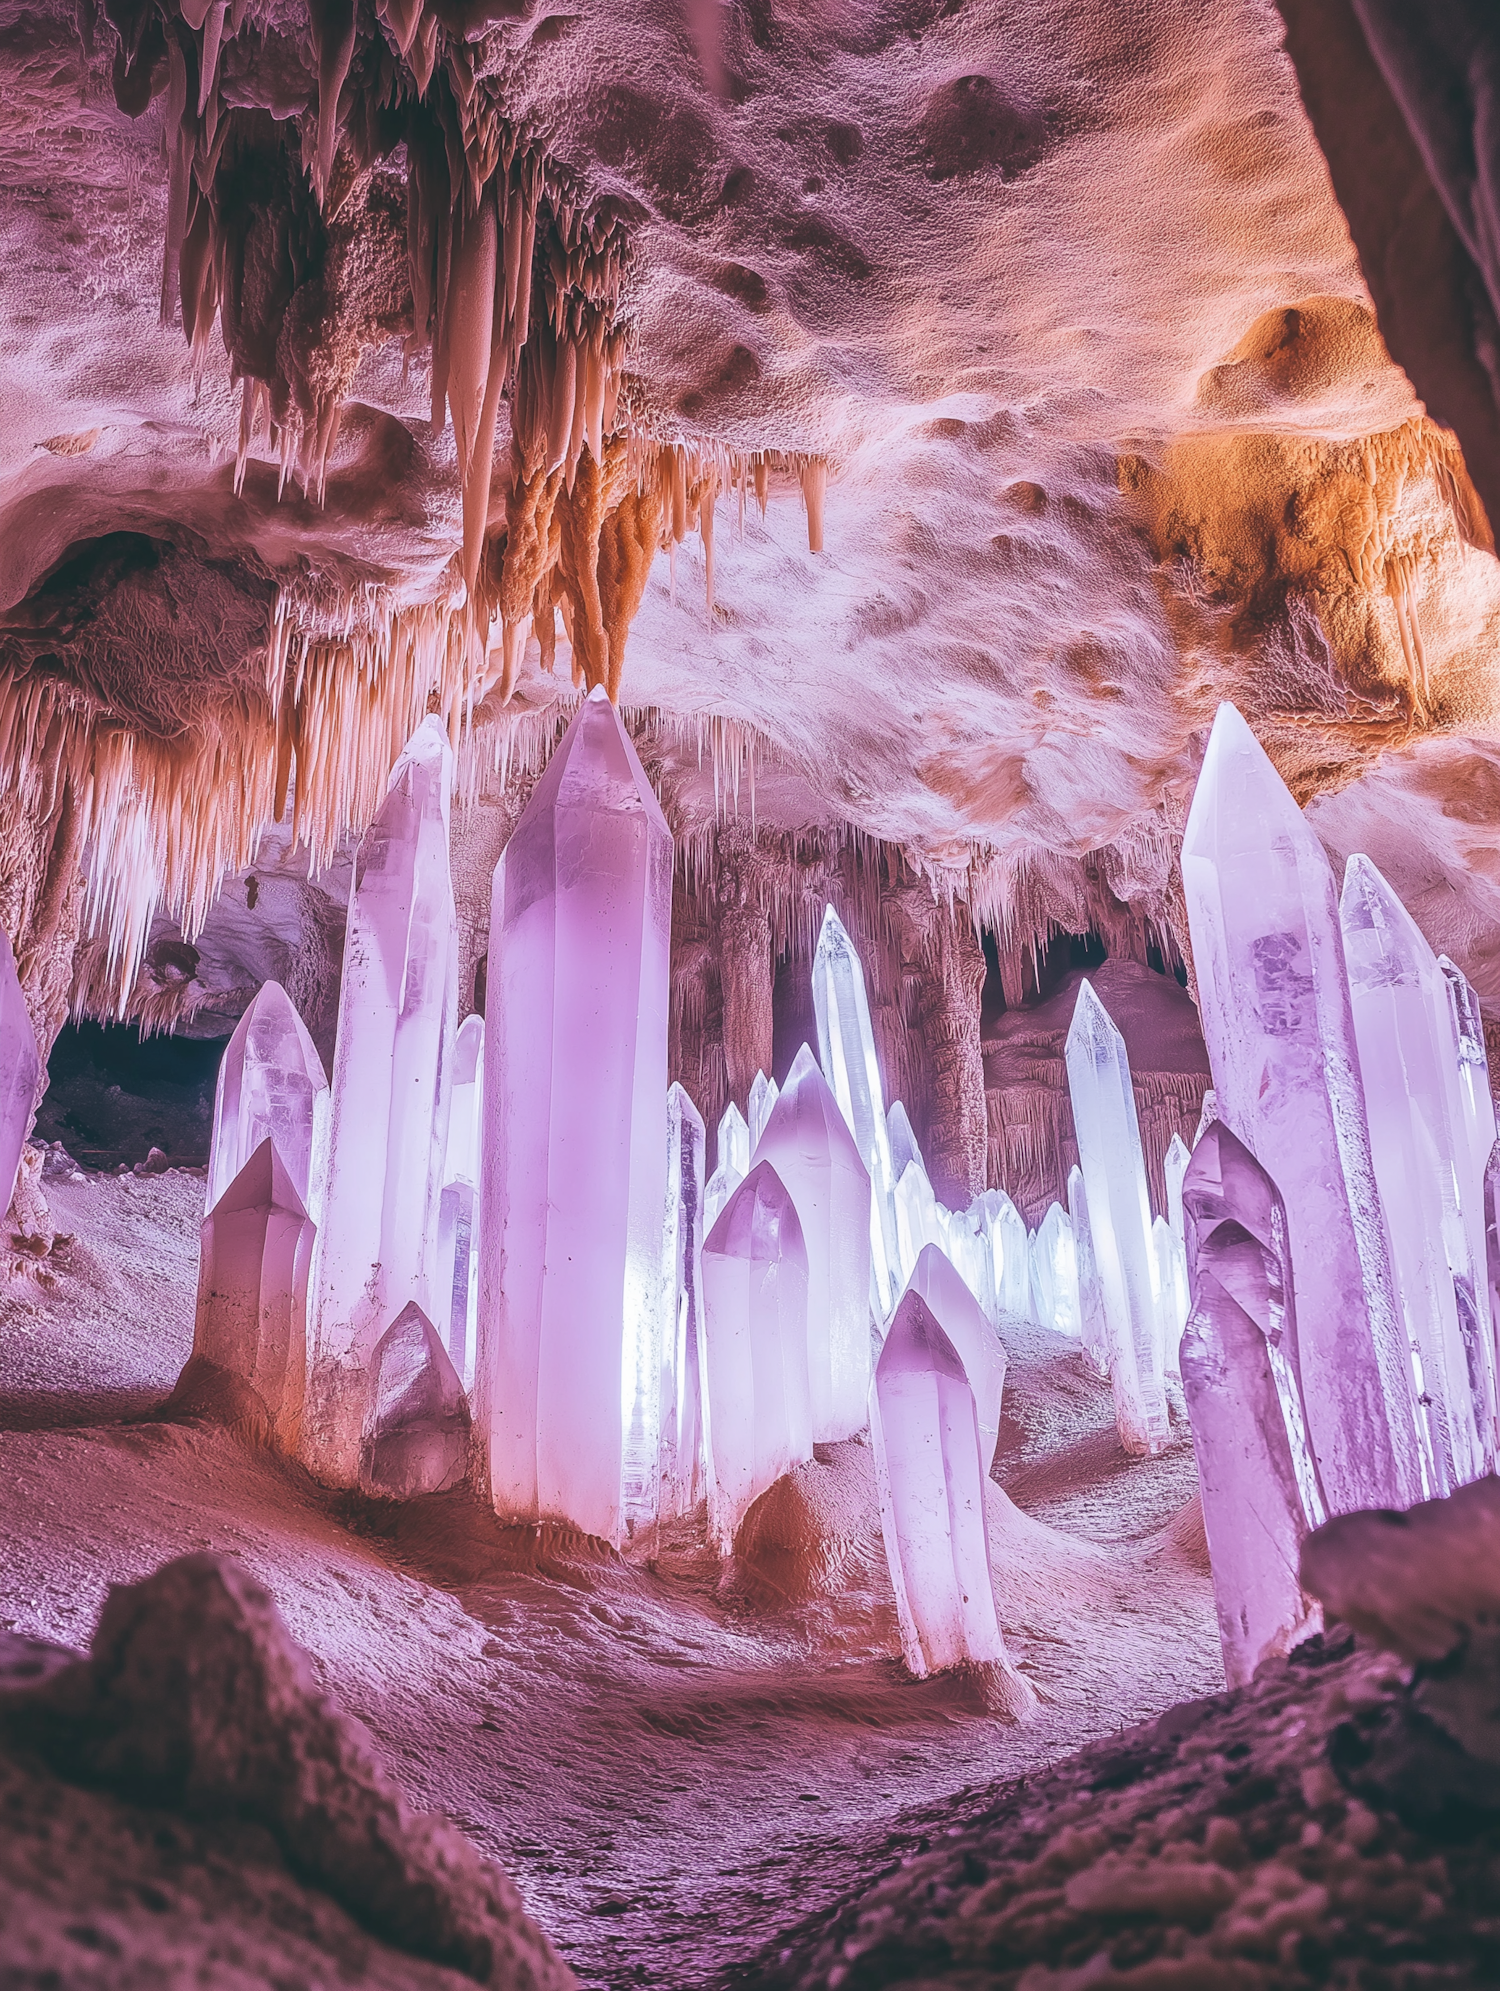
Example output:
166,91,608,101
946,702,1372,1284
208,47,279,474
193,1135,317,1451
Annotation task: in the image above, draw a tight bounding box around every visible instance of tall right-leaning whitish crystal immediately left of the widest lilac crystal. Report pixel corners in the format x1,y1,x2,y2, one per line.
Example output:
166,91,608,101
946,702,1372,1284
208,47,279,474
303,715,458,1485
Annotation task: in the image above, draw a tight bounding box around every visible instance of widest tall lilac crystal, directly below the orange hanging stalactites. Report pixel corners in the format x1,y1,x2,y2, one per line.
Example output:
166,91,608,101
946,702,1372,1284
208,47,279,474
474,687,671,1545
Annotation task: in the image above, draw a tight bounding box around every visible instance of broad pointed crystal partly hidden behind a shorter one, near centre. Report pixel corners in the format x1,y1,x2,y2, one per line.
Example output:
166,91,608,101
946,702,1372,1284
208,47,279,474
755,1045,871,1443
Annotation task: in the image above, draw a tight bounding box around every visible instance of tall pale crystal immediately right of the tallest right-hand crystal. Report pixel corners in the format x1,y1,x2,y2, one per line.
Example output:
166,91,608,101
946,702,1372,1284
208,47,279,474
1339,854,1494,1493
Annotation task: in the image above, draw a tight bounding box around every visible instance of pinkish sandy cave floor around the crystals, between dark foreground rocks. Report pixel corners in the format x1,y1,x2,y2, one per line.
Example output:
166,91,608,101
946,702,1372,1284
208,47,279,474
0,1175,1223,1987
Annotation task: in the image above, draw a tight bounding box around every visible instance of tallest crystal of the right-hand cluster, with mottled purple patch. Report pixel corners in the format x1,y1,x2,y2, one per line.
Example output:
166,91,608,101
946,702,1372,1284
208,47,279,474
1179,703,1422,1513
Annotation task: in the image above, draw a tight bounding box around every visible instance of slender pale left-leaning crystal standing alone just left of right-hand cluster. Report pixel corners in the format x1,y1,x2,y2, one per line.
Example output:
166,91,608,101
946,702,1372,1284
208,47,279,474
1064,982,1171,1457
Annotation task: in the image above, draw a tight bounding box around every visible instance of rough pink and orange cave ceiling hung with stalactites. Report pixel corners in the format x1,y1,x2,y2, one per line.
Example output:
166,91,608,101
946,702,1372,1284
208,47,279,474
0,0,1500,999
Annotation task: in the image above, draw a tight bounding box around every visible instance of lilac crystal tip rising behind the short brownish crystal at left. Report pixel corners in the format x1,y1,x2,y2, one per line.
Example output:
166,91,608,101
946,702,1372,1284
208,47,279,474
203,982,331,1222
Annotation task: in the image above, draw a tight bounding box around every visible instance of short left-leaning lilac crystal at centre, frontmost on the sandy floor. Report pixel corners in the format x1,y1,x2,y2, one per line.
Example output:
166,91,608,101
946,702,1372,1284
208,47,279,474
871,1290,1006,1678
